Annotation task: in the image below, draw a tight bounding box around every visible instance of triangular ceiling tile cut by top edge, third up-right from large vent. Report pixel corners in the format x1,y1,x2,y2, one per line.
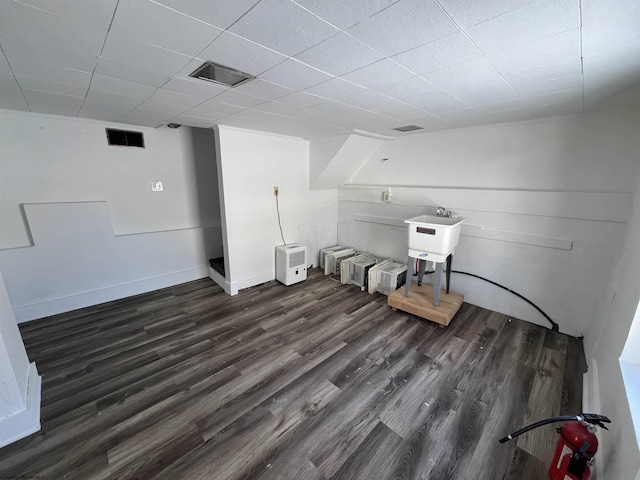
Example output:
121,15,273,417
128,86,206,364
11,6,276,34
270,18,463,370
295,0,398,30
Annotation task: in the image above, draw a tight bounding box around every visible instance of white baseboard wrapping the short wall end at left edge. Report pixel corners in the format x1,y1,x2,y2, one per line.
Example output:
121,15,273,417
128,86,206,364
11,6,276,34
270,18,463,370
0,363,42,448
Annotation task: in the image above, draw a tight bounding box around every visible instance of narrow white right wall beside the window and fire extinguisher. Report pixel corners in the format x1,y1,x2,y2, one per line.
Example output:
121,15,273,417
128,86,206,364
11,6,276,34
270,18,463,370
584,172,640,480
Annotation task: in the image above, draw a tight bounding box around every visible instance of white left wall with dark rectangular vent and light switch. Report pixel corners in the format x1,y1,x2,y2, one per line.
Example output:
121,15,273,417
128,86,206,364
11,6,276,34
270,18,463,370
0,111,215,321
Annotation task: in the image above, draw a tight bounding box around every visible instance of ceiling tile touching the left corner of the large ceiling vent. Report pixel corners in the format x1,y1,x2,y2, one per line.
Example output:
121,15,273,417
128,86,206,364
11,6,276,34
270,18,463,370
100,34,192,78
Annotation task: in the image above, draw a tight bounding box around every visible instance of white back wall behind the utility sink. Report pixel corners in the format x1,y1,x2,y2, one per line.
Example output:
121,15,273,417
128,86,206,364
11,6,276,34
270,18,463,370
338,109,640,336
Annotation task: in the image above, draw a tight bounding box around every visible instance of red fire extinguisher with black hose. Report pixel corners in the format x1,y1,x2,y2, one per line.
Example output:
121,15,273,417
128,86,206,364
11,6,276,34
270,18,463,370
500,413,611,480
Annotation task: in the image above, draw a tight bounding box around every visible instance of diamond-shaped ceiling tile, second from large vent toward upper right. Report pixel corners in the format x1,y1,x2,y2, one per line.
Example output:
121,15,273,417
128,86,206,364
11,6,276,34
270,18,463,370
229,0,339,56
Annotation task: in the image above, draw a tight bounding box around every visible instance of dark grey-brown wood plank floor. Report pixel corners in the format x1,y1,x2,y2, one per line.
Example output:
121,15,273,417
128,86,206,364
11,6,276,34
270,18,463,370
0,269,585,480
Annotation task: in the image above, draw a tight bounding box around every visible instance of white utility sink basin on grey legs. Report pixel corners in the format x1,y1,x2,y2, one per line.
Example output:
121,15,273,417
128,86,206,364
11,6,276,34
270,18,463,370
404,215,465,257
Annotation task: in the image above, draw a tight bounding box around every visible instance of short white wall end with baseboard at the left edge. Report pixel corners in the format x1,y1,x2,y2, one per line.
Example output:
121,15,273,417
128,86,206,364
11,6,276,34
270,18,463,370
0,271,41,448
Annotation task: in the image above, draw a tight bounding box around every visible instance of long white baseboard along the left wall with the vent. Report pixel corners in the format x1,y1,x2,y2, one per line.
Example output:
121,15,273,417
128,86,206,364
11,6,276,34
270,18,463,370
13,265,209,323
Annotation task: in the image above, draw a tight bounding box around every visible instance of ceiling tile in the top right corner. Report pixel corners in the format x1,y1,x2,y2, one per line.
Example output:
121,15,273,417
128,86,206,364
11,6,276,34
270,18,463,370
582,0,640,57
